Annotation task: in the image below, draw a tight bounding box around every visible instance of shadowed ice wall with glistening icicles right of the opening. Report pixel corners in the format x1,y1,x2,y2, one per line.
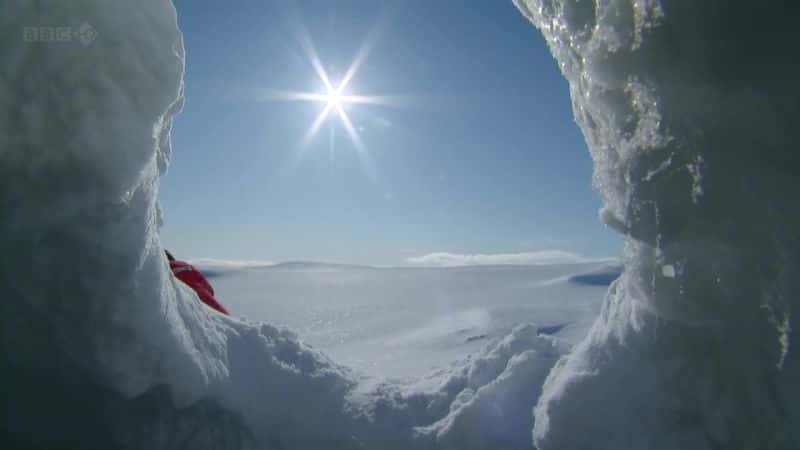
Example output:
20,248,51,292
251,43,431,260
515,0,800,450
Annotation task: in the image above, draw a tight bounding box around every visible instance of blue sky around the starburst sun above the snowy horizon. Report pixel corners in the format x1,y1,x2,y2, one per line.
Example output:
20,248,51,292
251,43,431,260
160,0,620,265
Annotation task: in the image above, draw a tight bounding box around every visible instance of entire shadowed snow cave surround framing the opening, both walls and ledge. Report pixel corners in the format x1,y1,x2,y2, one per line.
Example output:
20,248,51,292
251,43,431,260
0,0,800,449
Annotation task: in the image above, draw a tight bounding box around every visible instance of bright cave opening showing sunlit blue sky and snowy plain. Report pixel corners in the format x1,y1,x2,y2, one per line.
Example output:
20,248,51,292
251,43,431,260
160,0,621,377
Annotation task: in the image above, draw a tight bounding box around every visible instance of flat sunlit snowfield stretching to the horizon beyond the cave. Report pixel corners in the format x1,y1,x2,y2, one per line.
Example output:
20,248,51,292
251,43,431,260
198,261,619,379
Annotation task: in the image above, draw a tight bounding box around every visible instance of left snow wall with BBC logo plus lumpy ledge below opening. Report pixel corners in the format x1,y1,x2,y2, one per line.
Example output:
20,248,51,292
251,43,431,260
0,0,563,449
